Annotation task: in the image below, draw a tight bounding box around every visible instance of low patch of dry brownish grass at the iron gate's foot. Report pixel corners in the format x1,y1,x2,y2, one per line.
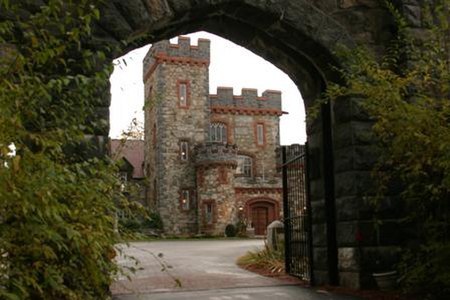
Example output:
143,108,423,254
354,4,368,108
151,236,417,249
237,243,284,274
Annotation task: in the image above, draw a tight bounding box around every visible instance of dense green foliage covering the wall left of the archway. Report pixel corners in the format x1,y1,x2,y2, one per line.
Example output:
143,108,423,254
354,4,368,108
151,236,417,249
0,0,127,299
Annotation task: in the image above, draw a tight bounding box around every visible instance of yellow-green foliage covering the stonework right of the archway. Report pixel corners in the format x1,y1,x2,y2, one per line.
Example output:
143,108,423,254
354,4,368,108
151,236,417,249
326,0,450,297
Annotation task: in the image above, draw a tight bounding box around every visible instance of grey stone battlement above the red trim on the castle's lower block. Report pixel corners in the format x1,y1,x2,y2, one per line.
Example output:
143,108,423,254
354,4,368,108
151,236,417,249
209,87,281,111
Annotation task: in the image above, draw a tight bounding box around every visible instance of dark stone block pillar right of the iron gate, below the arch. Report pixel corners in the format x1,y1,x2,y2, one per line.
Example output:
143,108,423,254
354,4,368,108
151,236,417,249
333,97,401,288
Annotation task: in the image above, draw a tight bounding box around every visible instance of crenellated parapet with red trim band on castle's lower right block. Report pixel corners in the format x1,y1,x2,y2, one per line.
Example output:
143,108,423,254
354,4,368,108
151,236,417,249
209,87,283,115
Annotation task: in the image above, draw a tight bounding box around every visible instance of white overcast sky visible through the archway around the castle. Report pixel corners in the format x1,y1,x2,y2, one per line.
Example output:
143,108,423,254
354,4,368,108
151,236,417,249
110,32,306,145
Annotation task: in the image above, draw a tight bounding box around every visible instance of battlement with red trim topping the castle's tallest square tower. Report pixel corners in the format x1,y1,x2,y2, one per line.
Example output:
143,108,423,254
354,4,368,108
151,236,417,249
144,36,210,76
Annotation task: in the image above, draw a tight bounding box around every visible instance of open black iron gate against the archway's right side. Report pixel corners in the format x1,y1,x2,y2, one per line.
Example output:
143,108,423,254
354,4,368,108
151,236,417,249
281,144,313,284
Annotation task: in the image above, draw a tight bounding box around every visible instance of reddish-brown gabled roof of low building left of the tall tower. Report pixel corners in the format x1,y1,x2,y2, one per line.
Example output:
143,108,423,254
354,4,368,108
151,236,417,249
111,139,144,178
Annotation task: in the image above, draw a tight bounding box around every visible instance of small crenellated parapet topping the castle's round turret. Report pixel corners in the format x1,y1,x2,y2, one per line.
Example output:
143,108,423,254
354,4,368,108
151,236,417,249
194,142,238,167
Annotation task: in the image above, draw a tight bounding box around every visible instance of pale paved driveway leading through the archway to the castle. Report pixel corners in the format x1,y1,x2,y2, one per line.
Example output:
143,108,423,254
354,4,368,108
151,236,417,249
111,240,356,300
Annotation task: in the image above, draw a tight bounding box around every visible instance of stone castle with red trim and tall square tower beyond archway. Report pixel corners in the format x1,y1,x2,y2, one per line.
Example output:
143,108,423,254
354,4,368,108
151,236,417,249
143,37,283,235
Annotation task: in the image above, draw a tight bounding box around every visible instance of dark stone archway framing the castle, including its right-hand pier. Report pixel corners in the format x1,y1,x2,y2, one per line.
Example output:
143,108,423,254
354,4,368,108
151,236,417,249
90,0,398,287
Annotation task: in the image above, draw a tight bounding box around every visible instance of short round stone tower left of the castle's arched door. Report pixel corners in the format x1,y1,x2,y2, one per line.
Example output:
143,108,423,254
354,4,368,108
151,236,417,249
195,142,238,235
